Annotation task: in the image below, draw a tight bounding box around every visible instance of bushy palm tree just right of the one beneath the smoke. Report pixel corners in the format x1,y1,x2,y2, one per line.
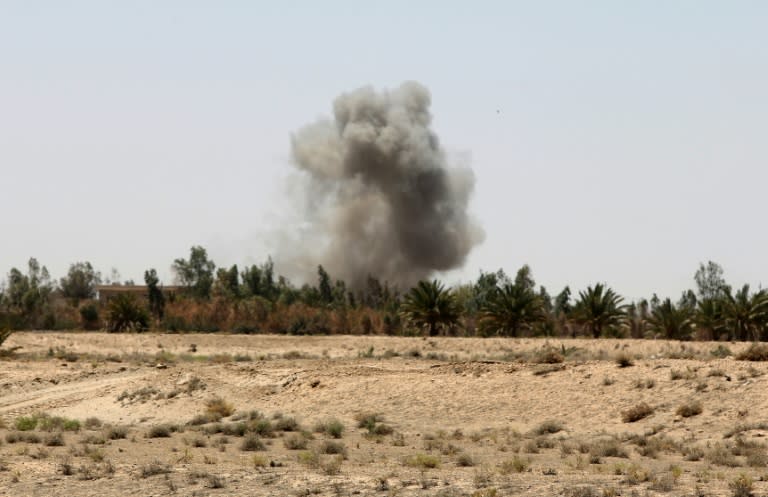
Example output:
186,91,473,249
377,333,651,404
480,283,544,337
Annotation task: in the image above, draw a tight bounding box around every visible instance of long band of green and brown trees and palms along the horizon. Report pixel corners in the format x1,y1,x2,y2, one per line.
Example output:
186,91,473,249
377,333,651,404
0,246,768,341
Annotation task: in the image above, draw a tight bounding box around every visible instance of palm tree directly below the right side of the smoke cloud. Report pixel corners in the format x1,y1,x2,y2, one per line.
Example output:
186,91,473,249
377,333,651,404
401,280,459,336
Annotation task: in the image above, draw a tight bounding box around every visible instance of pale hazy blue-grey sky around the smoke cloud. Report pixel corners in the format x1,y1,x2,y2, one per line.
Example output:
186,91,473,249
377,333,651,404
0,0,768,298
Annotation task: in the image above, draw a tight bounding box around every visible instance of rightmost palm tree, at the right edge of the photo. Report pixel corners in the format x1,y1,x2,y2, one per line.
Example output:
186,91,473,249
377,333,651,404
723,285,768,340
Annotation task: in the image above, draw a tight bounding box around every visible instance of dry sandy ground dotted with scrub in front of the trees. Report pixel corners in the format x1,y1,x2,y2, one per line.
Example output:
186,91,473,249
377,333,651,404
0,332,768,497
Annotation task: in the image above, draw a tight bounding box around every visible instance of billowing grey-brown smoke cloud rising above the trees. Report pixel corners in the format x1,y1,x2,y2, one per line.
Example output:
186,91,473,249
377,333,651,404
284,82,483,288
